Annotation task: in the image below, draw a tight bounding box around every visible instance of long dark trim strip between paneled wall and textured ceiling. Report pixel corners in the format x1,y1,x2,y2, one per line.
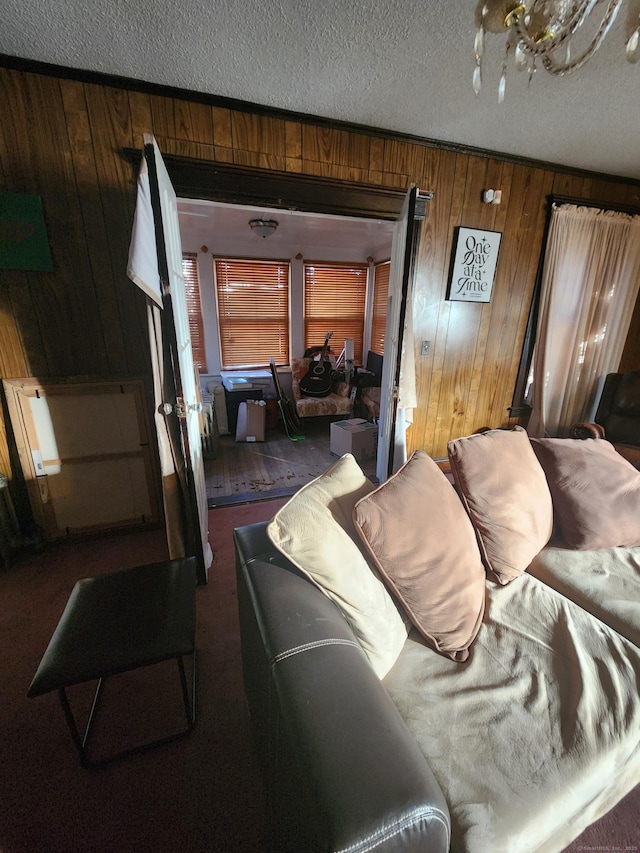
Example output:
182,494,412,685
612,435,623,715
5,53,640,186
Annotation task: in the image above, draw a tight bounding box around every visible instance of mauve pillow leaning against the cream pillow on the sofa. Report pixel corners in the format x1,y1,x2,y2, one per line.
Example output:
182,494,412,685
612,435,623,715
353,450,485,661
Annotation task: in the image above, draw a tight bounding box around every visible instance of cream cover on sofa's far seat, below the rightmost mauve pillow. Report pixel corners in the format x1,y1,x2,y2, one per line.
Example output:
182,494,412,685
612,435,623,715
527,545,640,647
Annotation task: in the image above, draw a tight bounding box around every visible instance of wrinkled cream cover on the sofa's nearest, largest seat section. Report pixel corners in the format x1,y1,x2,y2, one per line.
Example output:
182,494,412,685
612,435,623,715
384,575,640,853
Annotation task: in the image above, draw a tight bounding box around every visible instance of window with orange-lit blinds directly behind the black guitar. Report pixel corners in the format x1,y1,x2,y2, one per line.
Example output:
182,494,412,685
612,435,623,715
304,263,368,364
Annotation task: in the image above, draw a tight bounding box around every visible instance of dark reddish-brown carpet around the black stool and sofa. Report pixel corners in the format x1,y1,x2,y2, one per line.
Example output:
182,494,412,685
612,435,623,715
0,499,640,853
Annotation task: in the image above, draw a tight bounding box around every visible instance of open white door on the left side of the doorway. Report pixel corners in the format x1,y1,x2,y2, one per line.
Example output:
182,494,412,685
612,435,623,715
139,134,212,583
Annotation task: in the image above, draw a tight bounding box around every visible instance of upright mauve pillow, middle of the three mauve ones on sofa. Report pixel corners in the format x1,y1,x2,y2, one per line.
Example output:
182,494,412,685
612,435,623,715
448,427,553,584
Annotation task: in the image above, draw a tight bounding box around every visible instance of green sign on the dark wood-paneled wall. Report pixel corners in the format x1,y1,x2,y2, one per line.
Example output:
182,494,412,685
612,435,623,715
0,193,53,272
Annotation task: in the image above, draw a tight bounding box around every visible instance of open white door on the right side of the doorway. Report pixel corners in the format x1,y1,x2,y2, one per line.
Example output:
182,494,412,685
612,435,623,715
376,185,419,483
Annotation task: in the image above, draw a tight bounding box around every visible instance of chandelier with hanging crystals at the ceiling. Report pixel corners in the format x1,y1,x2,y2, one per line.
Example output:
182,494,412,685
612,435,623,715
473,0,640,103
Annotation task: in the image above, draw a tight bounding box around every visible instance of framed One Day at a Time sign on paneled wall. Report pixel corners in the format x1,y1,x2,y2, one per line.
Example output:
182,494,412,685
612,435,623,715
449,228,502,302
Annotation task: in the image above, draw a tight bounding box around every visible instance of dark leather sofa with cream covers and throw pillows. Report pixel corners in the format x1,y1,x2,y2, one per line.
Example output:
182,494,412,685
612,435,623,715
234,428,640,853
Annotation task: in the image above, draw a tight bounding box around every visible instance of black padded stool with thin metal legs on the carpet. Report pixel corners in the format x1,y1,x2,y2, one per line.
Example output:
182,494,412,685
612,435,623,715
27,557,196,766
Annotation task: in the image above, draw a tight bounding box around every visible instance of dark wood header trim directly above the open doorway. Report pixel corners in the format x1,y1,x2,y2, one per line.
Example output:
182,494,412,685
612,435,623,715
121,148,432,219
